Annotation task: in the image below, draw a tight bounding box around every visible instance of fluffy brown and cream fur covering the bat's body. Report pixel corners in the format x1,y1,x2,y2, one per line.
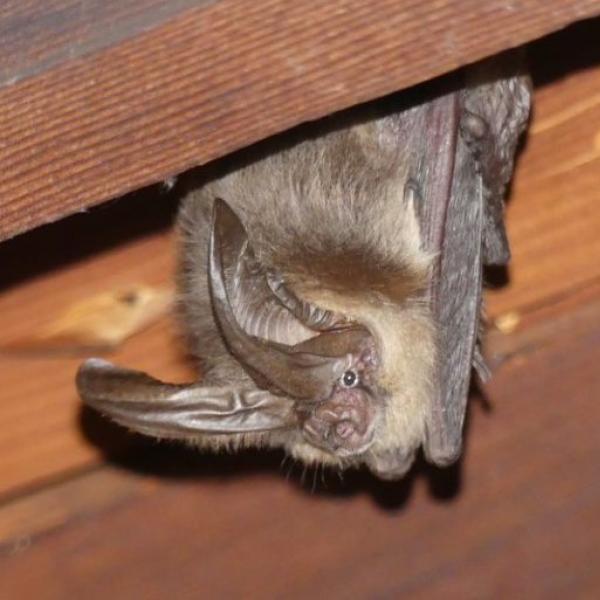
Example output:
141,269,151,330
179,111,435,465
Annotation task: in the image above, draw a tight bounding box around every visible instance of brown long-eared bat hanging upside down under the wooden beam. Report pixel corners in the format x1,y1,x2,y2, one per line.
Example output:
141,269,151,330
77,58,530,479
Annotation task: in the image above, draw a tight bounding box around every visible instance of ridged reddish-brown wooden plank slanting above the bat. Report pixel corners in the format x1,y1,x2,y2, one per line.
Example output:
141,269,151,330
0,0,600,239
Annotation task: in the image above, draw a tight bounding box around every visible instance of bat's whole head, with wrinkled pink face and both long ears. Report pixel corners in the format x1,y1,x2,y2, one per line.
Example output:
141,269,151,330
77,199,432,476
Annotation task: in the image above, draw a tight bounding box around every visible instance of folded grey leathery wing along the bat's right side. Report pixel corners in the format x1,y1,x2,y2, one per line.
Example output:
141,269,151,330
418,62,530,466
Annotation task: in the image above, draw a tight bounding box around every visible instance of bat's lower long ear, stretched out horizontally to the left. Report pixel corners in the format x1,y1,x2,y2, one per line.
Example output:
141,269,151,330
76,358,297,438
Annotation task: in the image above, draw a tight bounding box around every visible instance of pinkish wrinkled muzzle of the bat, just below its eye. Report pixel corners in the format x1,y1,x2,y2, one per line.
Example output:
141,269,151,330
302,389,377,457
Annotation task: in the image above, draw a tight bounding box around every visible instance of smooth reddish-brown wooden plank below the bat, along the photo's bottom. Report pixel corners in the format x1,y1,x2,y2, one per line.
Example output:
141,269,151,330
0,294,600,600
